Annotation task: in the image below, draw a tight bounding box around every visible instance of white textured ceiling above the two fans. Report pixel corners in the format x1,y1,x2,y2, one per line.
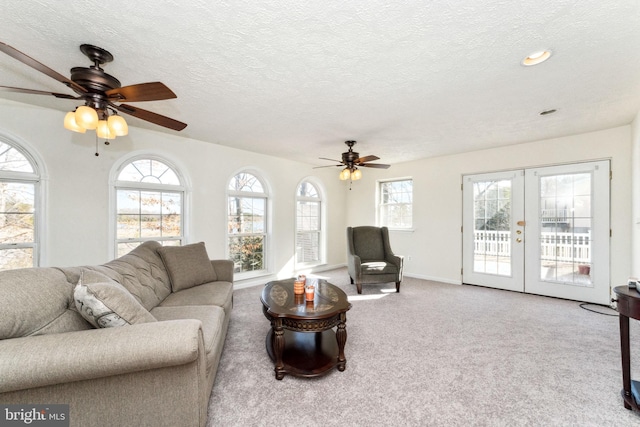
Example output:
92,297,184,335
0,0,640,165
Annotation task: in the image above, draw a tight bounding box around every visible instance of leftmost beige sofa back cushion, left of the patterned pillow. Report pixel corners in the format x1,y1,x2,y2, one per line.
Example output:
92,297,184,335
0,267,91,339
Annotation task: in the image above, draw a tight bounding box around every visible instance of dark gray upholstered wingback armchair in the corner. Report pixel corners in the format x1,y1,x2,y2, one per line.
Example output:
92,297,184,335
347,226,403,294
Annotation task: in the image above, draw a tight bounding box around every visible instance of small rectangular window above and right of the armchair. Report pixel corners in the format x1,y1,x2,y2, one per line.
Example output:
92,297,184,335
378,179,413,229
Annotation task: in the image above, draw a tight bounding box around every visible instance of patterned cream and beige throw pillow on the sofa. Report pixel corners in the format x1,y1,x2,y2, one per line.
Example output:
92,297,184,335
73,282,156,328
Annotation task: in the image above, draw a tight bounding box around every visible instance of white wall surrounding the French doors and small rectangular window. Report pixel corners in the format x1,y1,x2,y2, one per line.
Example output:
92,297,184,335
347,126,640,285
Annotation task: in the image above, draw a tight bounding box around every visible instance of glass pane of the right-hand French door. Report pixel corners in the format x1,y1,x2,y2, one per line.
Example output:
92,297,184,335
539,173,592,286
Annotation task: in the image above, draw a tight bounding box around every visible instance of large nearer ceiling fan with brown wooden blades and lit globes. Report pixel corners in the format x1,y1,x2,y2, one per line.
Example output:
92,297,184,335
0,42,187,135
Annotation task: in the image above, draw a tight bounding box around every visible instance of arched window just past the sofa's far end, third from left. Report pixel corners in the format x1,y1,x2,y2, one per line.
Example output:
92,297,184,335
227,172,268,277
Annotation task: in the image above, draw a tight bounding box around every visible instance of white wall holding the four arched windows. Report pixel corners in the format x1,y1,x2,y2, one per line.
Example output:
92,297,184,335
0,100,346,277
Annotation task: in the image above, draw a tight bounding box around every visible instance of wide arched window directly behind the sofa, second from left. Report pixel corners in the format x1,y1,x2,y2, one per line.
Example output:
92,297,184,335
115,156,185,257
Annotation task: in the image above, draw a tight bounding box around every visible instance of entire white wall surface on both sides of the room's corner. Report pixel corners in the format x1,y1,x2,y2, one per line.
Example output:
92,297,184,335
0,100,640,285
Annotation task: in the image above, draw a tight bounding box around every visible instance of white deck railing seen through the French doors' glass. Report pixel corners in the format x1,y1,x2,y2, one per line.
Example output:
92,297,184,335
474,230,591,263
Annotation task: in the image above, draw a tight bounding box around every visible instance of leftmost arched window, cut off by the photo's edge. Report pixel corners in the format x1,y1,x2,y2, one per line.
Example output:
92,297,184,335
0,138,41,270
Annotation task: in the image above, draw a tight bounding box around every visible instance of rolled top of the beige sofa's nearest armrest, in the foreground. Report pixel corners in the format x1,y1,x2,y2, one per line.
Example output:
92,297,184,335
0,319,204,392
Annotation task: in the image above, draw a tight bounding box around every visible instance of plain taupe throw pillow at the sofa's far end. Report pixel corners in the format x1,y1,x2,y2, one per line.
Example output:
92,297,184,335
158,242,218,292
